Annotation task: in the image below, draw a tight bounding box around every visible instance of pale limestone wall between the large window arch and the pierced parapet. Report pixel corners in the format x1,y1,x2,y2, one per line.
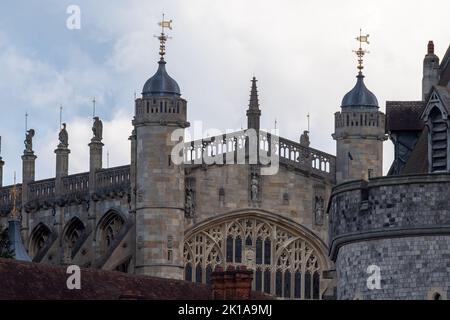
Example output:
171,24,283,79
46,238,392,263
186,165,332,242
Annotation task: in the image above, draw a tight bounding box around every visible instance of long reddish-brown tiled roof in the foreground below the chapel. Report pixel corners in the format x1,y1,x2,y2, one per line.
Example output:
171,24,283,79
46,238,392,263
0,259,272,300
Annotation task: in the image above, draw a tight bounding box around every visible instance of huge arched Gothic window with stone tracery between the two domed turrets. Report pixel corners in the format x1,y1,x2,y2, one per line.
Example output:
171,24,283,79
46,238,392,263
184,216,326,299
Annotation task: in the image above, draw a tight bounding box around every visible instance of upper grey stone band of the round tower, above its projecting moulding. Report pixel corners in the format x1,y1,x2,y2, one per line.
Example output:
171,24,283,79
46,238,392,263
328,174,450,260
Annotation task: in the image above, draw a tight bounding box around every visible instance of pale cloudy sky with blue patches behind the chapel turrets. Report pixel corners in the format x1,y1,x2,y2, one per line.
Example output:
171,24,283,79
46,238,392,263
0,0,450,184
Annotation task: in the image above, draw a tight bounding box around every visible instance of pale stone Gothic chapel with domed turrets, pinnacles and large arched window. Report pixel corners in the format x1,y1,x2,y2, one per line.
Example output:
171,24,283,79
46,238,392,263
0,24,449,299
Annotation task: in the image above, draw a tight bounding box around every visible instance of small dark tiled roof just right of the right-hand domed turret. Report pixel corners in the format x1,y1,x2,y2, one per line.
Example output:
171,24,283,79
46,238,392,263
386,101,425,132
